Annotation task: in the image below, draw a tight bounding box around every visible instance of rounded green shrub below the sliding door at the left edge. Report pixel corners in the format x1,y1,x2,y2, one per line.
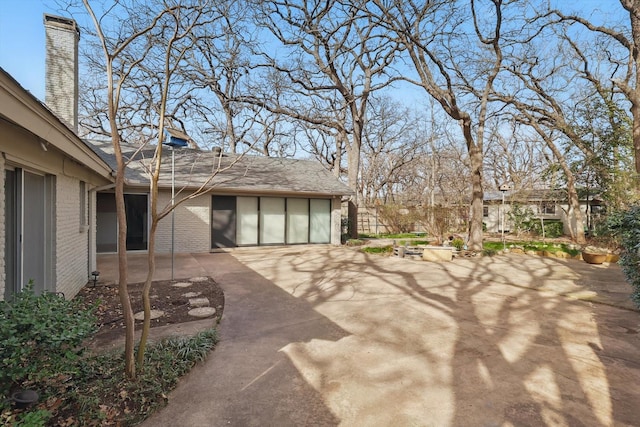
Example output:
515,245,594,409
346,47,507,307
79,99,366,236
0,284,96,396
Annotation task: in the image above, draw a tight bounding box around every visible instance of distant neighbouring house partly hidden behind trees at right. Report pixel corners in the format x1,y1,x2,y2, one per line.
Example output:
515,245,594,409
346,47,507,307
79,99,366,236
482,189,600,235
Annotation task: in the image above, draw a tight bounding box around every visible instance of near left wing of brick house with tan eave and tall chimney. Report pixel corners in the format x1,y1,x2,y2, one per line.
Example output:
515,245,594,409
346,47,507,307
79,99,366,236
0,16,111,298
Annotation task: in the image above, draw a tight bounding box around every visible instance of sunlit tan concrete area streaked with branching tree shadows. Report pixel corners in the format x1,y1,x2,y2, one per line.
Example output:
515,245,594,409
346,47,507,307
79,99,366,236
237,247,640,426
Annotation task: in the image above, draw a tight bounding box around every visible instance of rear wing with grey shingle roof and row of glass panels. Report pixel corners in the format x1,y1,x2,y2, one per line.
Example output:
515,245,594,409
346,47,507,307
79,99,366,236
92,142,351,253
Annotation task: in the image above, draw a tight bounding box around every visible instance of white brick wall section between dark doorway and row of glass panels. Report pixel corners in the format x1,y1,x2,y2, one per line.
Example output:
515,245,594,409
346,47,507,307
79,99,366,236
155,191,211,253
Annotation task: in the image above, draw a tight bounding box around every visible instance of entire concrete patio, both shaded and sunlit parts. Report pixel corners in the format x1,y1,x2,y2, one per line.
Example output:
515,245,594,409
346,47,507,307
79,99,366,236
99,246,640,426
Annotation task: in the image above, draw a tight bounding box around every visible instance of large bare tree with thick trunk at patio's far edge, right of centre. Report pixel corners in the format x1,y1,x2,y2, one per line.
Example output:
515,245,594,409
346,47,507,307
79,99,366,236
369,0,503,250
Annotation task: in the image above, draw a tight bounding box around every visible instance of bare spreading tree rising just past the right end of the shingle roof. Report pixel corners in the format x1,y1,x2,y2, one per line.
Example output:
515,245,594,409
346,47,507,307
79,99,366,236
249,0,397,236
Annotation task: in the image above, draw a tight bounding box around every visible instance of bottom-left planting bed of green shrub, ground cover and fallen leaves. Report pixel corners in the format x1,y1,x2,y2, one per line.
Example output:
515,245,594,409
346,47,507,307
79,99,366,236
0,289,218,426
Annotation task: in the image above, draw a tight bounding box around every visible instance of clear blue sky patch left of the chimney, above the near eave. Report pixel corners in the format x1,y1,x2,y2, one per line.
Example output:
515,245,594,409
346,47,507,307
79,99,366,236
0,0,59,100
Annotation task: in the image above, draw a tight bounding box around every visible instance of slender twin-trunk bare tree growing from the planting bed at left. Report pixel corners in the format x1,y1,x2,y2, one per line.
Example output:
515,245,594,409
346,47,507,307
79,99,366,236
82,0,222,378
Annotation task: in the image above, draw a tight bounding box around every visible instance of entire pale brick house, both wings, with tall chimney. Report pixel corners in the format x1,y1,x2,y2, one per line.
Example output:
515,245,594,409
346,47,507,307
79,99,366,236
0,15,351,299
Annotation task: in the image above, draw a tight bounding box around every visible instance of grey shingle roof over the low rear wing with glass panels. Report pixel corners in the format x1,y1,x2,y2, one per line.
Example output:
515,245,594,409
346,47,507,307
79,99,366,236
89,141,353,196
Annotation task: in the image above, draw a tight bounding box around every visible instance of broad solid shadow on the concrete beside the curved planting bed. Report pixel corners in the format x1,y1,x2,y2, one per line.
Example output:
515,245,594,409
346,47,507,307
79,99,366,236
145,253,346,426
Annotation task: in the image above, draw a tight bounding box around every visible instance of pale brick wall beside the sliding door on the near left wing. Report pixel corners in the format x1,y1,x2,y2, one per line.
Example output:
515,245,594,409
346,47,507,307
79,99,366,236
56,175,89,299
